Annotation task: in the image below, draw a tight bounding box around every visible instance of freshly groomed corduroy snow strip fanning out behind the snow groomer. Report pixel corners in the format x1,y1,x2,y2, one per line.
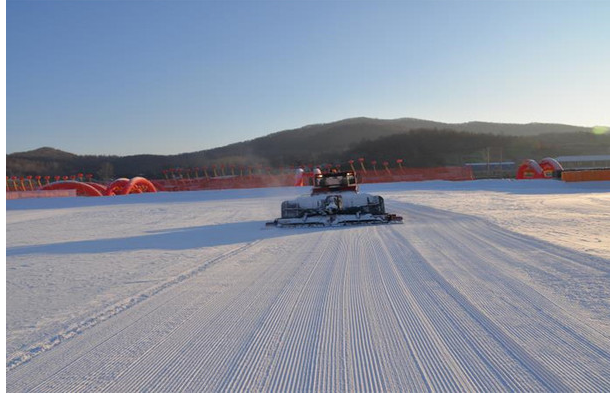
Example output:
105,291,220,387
7,203,609,392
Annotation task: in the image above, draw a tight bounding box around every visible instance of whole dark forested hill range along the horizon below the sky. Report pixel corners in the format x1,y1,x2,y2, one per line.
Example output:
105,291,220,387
7,118,609,178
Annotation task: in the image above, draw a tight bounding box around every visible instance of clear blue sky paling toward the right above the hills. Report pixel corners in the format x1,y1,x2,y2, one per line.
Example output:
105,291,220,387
6,0,610,155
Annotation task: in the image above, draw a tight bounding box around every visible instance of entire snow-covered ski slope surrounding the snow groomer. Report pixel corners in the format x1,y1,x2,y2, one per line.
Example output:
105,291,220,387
6,181,610,392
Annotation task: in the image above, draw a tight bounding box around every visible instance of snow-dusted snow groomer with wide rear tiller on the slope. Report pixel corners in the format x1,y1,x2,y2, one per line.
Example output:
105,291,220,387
266,172,403,227
